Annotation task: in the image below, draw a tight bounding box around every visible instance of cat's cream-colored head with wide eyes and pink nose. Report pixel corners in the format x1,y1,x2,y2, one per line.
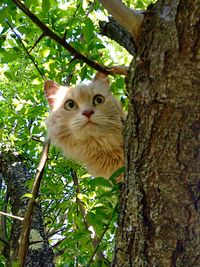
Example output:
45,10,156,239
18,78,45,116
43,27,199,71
44,73,124,140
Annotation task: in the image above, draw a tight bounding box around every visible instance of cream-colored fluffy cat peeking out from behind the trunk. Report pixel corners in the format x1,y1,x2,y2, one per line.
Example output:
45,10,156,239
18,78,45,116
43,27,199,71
44,73,125,181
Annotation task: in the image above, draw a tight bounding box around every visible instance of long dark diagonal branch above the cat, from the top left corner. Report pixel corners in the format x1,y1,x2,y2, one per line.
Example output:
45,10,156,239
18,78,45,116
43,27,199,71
12,0,127,75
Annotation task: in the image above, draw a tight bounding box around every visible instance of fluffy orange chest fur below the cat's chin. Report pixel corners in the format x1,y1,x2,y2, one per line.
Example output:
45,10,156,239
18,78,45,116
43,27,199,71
64,132,124,178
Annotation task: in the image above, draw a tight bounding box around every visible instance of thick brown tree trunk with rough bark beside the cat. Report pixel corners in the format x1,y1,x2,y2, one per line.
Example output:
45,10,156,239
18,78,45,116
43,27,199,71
113,0,200,267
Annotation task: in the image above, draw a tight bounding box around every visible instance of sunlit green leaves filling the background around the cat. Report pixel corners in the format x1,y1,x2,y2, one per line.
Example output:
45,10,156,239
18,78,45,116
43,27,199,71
0,0,153,266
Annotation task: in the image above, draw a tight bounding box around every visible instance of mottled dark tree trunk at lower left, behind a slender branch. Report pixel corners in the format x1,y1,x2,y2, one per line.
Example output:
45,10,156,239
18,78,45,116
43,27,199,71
0,152,54,267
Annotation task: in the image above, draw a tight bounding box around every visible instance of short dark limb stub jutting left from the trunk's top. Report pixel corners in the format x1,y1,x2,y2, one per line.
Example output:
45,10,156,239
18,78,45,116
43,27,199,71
99,17,136,55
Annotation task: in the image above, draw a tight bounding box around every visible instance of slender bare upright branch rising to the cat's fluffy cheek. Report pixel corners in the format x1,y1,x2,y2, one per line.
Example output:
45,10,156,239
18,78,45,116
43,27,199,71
18,141,50,267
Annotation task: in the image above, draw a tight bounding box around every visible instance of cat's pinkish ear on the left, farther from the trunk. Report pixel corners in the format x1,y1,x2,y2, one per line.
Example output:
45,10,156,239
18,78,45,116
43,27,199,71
44,80,60,109
